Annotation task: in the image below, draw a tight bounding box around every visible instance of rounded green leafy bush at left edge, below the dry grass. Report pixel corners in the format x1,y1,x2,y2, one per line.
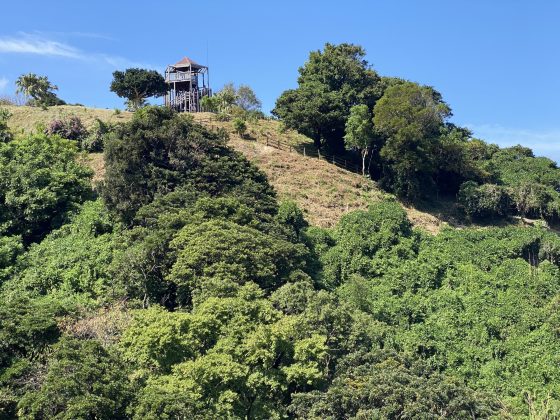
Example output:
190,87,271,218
0,136,92,242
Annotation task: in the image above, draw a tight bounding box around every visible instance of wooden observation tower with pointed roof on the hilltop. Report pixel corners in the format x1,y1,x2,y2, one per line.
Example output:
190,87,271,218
165,57,212,112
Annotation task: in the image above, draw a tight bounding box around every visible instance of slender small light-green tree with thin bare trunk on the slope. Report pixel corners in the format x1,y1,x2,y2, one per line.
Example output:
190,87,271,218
344,105,375,175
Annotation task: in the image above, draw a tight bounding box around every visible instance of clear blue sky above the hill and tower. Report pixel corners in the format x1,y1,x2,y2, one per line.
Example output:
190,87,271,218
0,0,560,161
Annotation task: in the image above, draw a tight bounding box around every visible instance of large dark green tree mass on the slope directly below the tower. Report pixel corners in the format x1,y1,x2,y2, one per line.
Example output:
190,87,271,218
102,107,276,223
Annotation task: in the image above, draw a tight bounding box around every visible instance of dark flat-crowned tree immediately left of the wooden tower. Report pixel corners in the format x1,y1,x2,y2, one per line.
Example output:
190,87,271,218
111,68,167,110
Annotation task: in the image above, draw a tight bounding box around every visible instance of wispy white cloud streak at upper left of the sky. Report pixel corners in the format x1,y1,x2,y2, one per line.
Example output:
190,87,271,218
0,33,155,68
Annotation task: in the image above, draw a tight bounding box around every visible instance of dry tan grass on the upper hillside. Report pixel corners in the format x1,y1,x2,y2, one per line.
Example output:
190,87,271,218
7,106,460,233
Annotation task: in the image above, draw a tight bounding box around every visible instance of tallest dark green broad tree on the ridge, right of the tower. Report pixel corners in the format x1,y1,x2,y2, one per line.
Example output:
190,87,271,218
272,44,382,152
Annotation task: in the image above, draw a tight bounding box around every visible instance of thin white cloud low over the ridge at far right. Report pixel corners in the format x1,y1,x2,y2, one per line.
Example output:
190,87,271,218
467,124,560,161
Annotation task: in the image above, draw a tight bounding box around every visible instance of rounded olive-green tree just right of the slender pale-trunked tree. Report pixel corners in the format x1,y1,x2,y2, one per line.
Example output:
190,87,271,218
374,82,451,199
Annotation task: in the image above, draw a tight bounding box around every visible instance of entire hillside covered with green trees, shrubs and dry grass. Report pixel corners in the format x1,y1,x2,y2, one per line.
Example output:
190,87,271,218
0,44,560,420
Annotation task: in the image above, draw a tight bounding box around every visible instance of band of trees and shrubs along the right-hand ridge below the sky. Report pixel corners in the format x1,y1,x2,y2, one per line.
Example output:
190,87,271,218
272,44,560,222
